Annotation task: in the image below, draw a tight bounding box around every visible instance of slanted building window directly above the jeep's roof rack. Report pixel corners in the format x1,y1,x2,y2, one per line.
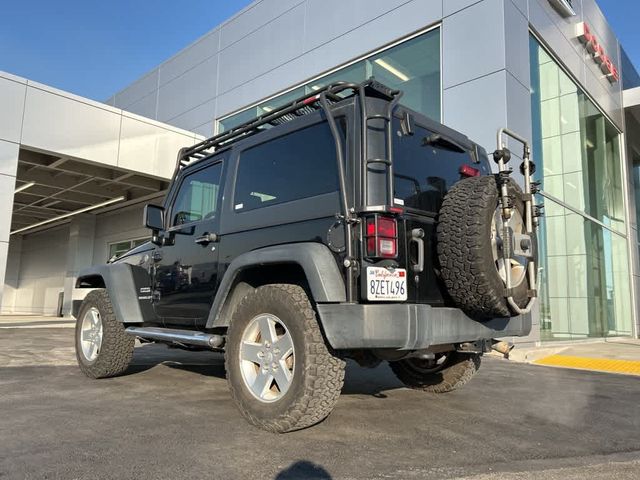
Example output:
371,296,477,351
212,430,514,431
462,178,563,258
218,28,441,132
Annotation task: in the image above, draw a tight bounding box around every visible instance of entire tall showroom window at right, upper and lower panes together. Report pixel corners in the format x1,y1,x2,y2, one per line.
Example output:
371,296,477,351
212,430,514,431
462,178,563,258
530,37,632,340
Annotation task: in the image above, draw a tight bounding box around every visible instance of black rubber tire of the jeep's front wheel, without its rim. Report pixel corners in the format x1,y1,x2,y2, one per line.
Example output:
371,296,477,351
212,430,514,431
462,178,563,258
75,289,135,378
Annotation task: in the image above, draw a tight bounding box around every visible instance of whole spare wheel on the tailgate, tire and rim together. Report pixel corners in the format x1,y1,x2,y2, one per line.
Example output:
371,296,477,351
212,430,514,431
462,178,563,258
437,176,537,319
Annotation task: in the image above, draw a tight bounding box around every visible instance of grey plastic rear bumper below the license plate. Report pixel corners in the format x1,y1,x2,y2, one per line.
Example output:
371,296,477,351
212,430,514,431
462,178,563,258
318,303,531,350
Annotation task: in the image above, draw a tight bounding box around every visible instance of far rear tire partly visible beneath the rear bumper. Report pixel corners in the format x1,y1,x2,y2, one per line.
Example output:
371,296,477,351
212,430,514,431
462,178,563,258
389,352,481,393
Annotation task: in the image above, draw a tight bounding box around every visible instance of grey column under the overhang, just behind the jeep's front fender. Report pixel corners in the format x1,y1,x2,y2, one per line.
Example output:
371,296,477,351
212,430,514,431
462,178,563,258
62,214,96,316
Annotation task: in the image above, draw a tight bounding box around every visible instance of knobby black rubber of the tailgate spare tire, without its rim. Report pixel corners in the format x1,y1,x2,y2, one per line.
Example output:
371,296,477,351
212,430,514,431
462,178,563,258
437,176,526,319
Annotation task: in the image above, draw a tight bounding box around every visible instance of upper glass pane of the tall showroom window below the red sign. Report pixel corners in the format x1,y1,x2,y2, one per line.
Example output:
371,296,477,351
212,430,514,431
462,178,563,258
531,39,625,233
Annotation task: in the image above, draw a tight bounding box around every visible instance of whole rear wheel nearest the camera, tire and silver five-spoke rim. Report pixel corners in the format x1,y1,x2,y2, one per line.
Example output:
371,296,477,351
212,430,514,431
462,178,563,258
225,284,345,433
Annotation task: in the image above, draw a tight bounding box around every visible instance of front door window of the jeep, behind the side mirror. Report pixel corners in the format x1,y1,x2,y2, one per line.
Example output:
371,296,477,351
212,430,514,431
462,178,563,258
171,163,222,226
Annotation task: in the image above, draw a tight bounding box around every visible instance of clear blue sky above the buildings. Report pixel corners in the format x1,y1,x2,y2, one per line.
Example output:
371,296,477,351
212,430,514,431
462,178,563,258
0,0,640,100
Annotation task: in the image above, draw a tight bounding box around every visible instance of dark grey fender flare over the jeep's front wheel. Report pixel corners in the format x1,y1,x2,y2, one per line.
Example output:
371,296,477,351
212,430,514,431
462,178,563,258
75,263,153,323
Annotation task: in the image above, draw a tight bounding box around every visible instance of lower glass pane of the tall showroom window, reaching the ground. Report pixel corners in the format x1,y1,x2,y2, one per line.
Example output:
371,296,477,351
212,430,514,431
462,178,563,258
539,200,632,340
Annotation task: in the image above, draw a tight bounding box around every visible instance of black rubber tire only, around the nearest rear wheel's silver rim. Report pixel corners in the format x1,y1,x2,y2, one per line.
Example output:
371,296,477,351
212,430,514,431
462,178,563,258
225,284,346,433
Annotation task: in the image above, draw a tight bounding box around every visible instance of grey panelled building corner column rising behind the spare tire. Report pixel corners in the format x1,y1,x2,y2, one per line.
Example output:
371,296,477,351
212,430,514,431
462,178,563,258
442,0,540,344
